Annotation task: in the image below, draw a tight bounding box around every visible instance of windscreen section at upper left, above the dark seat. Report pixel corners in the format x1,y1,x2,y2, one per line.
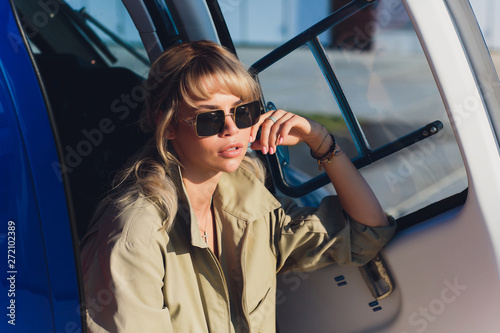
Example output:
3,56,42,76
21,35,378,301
15,0,149,76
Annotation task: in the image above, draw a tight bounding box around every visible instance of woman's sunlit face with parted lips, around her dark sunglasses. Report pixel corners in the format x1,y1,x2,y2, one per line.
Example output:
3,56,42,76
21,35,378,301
168,93,251,181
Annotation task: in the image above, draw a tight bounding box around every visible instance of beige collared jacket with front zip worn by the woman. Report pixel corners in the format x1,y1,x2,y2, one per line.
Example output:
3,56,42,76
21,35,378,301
81,168,395,333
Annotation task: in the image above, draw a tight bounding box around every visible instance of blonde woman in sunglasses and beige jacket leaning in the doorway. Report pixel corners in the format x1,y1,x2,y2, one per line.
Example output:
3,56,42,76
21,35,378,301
81,41,395,333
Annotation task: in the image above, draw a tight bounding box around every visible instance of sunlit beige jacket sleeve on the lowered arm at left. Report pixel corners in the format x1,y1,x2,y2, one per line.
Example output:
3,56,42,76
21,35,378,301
82,204,174,333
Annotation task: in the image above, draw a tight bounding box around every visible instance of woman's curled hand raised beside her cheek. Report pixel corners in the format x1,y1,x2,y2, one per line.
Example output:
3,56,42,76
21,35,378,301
250,110,328,154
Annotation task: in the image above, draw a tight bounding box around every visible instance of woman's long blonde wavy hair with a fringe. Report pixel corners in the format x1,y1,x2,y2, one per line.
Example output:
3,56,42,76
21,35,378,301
101,41,265,231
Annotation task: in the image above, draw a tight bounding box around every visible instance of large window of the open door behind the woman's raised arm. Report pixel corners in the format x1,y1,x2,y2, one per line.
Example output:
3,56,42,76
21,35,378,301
220,0,466,217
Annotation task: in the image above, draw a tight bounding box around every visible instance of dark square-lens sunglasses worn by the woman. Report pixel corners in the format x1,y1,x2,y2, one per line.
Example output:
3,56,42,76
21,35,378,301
181,100,262,137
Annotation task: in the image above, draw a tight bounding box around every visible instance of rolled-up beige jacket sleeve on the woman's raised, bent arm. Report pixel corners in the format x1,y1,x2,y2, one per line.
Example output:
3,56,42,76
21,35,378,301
274,196,396,273
